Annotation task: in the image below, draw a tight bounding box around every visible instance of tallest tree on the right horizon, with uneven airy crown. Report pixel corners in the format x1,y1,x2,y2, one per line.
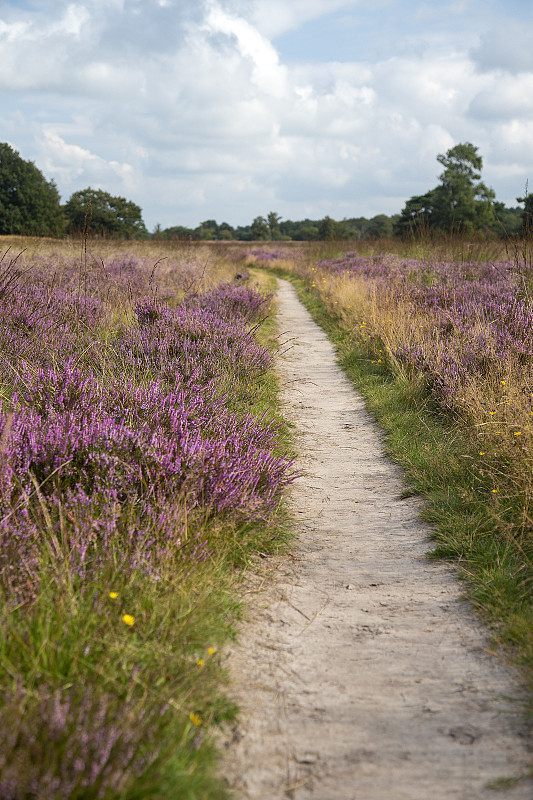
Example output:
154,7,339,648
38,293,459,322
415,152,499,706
396,142,495,234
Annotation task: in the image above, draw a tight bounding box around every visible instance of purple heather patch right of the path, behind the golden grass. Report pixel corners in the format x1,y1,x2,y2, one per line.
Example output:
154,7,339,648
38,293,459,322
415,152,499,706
318,253,533,411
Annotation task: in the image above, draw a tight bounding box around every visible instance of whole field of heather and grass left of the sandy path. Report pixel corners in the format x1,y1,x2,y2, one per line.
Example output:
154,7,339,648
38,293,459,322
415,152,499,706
0,240,293,800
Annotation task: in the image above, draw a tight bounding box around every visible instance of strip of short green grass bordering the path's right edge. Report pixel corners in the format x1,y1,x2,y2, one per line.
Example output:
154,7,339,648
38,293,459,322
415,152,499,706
270,273,533,712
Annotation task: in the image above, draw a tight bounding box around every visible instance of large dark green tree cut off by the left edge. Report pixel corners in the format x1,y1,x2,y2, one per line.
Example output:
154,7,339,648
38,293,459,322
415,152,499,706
0,143,64,236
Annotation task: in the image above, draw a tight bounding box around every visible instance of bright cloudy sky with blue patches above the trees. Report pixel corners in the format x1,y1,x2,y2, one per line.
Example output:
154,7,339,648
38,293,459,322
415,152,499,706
0,0,533,229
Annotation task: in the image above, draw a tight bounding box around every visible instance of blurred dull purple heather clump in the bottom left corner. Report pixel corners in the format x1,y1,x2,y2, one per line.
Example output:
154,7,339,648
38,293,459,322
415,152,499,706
0,687,159,800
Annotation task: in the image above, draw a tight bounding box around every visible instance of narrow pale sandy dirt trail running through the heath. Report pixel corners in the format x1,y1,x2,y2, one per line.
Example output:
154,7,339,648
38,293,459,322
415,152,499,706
219,281,533,800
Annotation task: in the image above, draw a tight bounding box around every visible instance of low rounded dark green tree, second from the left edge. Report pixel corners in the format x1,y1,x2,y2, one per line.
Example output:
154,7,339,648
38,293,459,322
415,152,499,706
65,187,148,239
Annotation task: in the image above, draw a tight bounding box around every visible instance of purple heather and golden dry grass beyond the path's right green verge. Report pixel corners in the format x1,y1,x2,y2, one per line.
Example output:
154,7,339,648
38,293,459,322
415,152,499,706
304,253,533,552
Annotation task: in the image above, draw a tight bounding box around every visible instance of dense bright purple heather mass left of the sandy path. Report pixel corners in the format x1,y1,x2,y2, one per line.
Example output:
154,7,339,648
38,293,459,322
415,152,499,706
0,296,289,592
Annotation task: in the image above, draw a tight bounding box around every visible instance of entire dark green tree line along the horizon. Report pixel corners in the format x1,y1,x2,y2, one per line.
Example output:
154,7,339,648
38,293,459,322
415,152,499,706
0,142,533,241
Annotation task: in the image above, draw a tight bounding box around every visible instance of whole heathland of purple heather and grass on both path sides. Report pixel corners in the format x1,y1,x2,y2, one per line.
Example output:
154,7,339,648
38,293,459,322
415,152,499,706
0,234,533,800
